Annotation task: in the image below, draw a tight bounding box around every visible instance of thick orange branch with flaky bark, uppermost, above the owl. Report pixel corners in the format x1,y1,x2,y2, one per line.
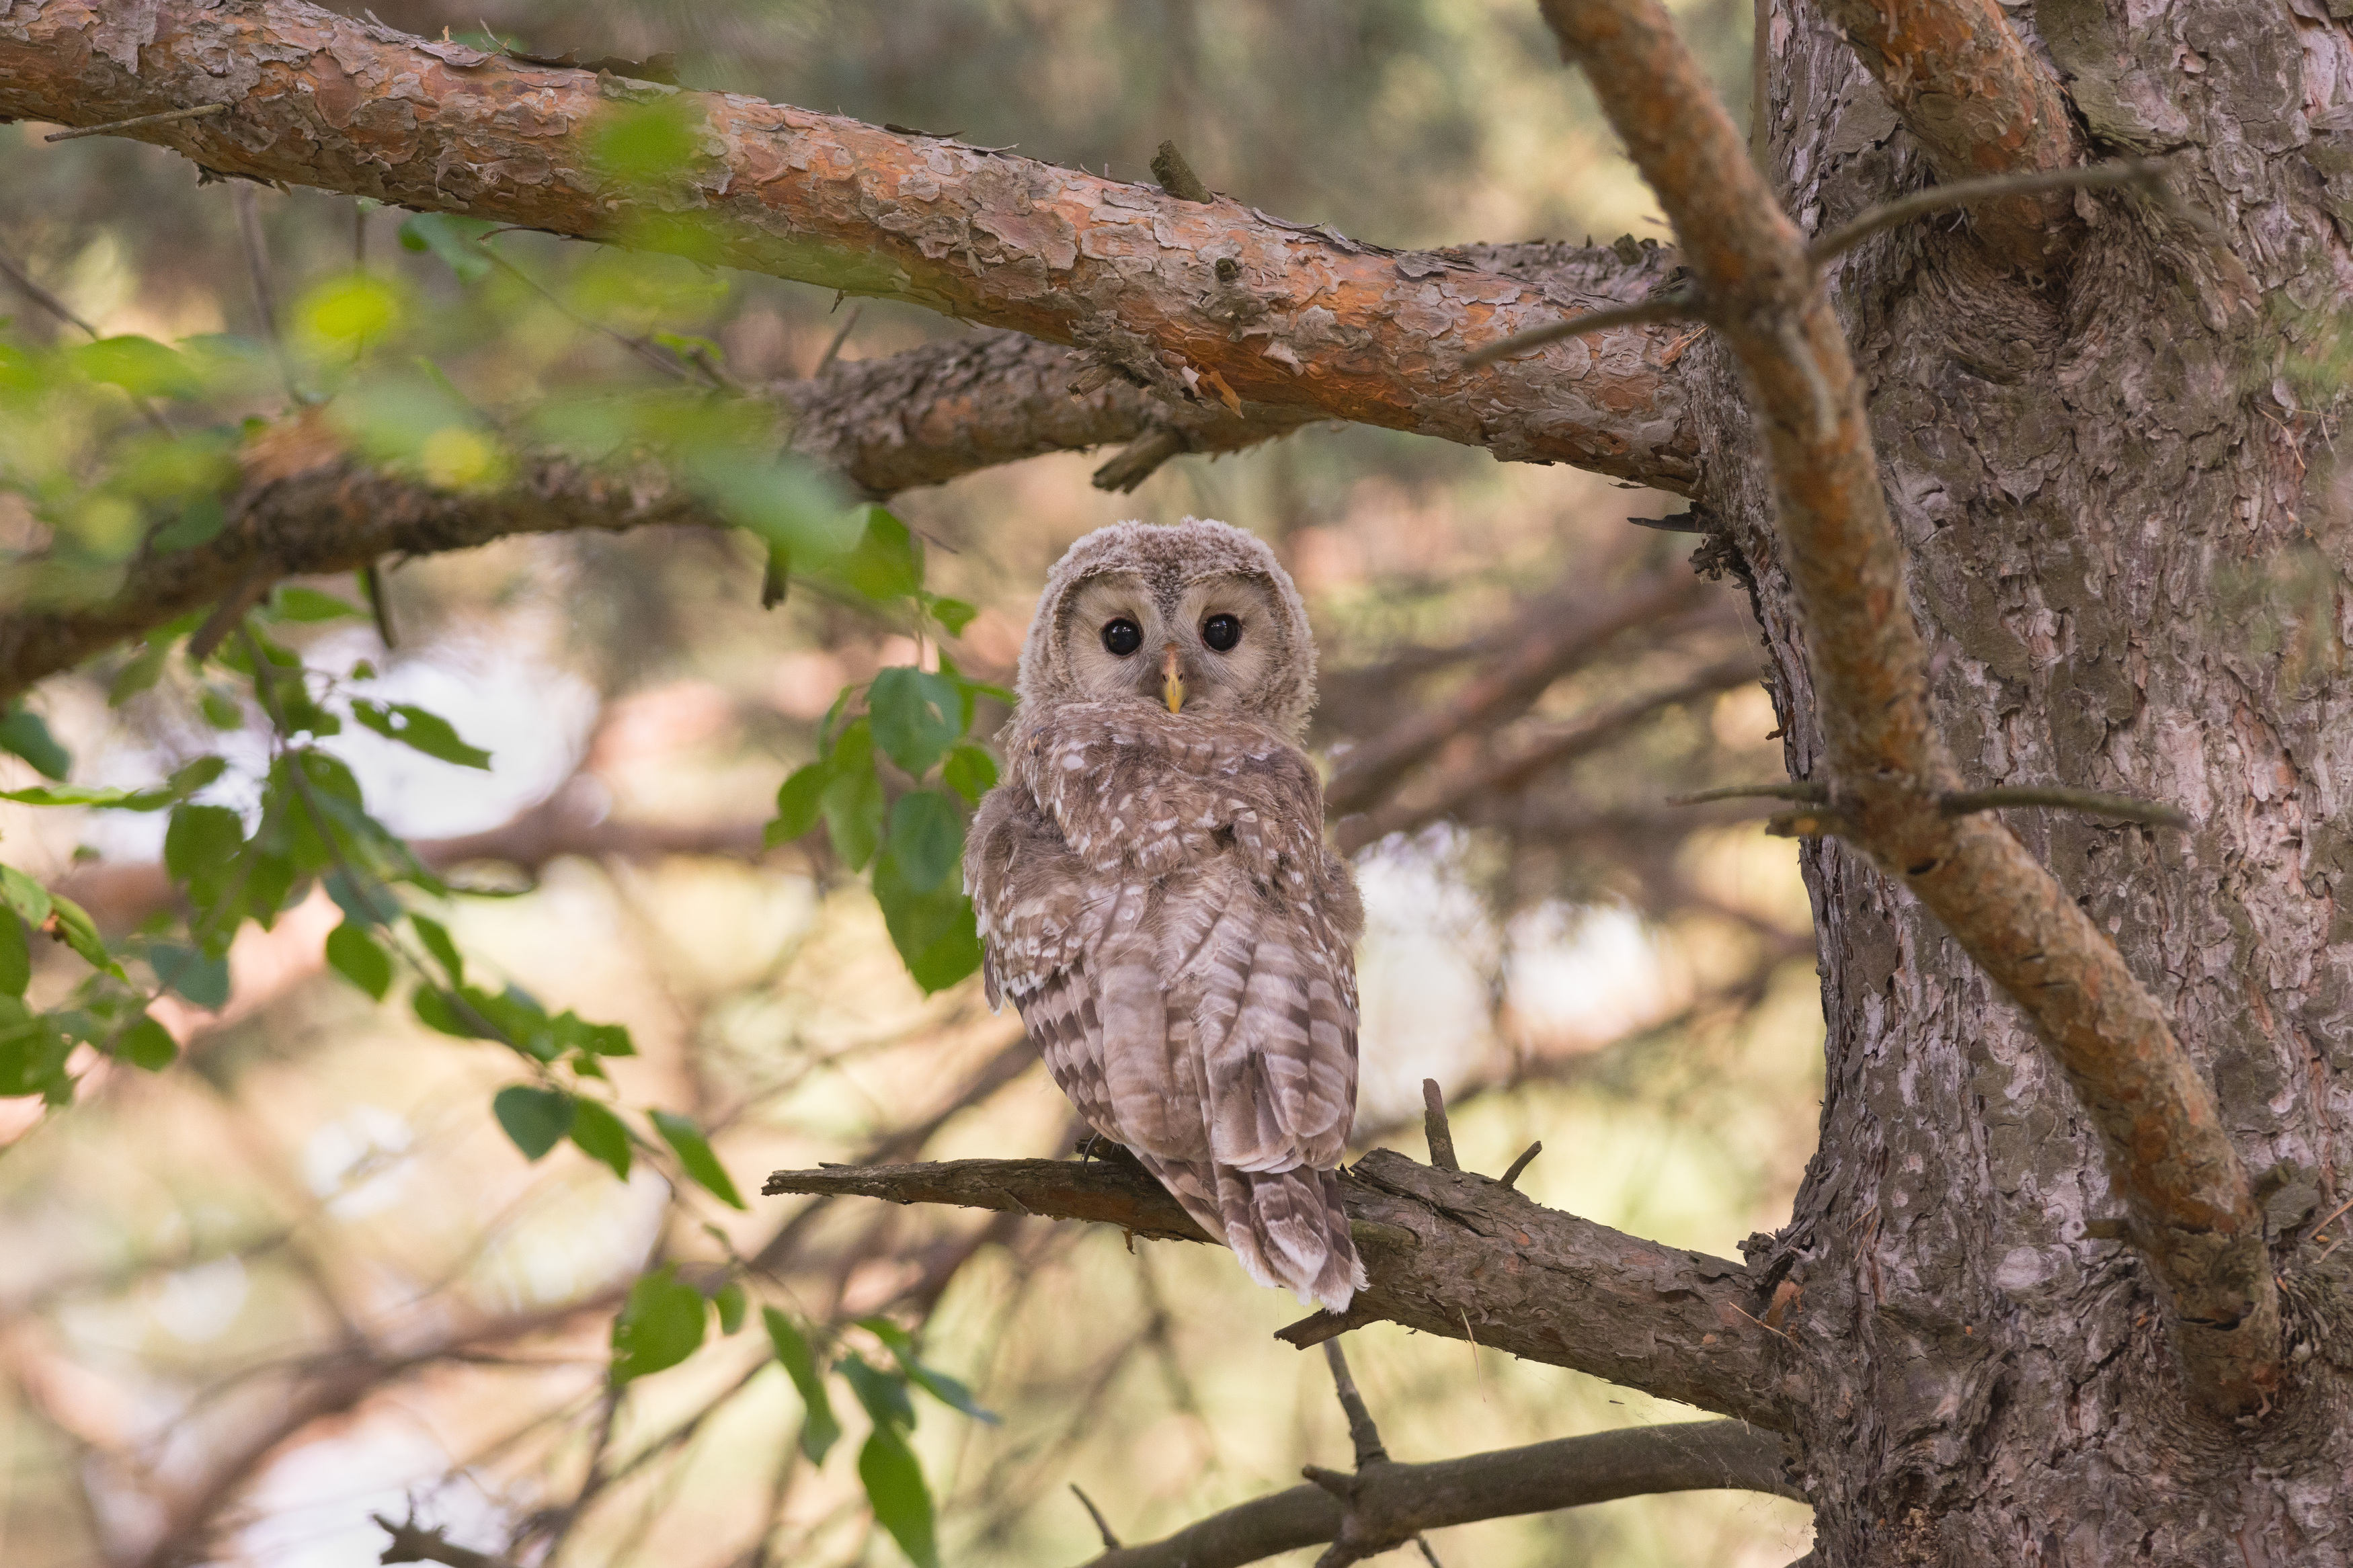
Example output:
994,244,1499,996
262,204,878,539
0,0,1697,489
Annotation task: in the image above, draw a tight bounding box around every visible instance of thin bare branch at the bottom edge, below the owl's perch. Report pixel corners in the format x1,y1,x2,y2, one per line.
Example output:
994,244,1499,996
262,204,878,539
1087,1420,1805,1568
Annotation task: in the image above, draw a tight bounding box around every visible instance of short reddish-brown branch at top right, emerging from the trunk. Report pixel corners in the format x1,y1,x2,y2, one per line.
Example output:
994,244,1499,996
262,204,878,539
1821,0,2085,270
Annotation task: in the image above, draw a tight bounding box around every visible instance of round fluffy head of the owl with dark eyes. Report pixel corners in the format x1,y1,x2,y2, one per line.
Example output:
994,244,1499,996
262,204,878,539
1019,518,1316,741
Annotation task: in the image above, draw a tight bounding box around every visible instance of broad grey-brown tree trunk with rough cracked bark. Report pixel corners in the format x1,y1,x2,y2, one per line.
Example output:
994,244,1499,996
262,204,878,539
1722,0,2353,1568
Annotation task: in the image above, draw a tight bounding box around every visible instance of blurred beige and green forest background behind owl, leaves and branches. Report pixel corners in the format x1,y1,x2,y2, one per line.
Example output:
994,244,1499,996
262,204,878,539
0,0,1821,1568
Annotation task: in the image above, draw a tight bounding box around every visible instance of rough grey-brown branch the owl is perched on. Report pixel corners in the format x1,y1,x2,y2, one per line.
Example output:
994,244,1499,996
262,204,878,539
762,1149,1796,1430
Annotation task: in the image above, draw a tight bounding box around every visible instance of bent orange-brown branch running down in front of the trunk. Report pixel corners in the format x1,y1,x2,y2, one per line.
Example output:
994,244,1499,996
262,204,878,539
1544,0,2280,1415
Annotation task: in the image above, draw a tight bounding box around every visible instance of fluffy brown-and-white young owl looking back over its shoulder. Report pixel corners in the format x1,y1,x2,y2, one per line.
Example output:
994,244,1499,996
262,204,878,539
965,518,1365,1312
